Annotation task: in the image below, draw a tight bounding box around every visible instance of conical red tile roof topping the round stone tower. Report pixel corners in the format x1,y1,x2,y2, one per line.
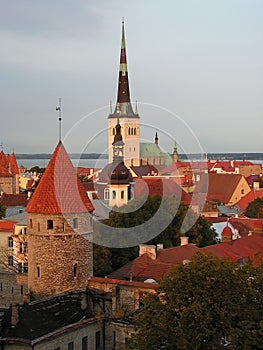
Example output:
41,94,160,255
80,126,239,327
26,141,94,214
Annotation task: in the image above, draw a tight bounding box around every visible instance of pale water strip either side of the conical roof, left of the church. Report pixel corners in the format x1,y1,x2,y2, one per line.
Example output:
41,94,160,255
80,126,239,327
17,159,108,169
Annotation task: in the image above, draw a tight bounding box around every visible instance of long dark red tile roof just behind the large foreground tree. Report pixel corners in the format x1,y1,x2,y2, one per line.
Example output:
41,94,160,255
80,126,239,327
109,234,263,281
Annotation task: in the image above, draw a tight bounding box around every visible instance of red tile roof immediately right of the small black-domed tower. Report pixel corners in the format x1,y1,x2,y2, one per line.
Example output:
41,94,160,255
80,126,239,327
134,176,192,204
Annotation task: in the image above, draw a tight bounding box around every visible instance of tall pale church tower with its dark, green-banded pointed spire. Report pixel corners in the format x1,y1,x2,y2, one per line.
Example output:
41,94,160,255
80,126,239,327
108,20,140,166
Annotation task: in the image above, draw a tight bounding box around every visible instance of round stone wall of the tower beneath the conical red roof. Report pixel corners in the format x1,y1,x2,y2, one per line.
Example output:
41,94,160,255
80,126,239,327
27,213,93,294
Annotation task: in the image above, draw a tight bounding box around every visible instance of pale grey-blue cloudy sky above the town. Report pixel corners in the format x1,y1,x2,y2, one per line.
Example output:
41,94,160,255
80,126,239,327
0,0,263,153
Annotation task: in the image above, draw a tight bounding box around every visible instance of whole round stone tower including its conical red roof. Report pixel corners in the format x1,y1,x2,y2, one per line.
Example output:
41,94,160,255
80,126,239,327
27,141,94,295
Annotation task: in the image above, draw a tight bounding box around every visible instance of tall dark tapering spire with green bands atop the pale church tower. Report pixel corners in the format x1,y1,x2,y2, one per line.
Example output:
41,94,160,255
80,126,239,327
114,19,134,115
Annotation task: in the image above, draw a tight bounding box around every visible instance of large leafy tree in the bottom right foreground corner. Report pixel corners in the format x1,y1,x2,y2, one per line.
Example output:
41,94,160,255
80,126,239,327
130,254,263,350
